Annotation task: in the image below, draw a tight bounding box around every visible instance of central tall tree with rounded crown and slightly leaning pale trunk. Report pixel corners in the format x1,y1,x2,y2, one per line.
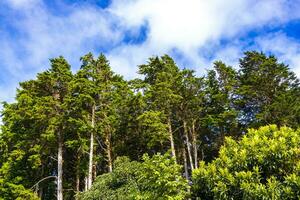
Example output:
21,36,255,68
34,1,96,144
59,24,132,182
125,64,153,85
139,55,181,160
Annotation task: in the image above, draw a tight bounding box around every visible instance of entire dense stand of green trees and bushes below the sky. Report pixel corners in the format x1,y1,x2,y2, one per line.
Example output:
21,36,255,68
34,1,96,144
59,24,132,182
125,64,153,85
0,51,300,200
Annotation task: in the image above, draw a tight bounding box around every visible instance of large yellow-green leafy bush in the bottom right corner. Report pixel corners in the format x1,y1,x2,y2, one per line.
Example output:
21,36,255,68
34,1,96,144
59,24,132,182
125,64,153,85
193,125,300,199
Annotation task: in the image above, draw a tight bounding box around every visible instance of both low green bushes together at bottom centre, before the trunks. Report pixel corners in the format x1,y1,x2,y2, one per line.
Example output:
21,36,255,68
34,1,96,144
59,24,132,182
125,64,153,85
78,154,189,200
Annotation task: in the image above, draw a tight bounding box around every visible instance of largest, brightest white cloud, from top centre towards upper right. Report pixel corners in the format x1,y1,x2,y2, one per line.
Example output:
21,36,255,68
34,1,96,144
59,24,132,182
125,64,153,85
110,0,298,50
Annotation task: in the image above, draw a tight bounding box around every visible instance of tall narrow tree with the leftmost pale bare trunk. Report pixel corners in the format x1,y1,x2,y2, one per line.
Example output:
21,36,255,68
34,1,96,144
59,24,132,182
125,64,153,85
35,57,72,200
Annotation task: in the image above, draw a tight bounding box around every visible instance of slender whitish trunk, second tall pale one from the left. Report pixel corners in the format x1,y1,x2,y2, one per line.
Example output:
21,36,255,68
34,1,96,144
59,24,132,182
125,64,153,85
87,105,95,189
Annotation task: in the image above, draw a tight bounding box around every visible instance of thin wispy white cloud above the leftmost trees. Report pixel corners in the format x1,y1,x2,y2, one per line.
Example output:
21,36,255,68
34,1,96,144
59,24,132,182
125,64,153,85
0,0,122,101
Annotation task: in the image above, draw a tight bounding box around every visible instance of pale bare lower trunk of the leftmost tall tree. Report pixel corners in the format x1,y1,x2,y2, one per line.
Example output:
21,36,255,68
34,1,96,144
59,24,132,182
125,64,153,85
57,131,63,200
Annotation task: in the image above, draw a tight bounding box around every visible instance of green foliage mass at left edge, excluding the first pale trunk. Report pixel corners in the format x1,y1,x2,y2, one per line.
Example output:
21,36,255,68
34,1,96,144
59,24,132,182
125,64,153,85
0,57,72,199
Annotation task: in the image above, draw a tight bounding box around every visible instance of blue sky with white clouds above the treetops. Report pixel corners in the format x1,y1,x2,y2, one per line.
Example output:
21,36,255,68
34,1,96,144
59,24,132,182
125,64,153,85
0,0,300,102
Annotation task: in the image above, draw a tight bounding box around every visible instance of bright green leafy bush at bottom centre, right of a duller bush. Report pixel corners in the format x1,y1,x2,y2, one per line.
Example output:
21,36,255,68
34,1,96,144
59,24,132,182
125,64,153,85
138,154,189,200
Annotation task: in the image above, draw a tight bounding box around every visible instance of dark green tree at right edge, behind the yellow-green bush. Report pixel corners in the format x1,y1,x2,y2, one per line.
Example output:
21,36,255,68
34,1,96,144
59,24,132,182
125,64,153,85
235,51,300,128
